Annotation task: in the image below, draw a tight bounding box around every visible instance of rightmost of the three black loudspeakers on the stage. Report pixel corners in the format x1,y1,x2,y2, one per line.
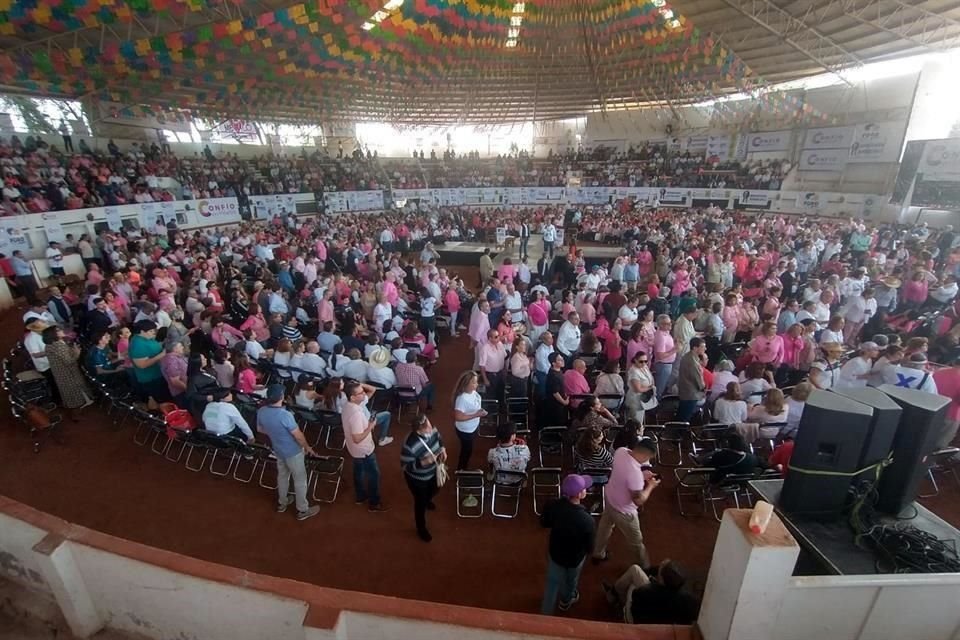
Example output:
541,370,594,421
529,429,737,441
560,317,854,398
877,384,950,515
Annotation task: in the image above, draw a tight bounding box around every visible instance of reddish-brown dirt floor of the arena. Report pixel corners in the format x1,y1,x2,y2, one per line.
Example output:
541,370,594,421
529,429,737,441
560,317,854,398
0,269,960,620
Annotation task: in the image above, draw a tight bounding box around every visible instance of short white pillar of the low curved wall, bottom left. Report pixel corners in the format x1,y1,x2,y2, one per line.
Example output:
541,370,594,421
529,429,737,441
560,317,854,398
33,534,104,638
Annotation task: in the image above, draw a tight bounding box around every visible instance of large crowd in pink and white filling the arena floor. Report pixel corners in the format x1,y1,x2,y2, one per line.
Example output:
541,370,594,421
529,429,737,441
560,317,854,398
12,192,960,623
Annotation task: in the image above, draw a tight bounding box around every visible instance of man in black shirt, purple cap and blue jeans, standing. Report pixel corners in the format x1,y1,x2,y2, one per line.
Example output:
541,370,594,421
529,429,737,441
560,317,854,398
540,474,596,616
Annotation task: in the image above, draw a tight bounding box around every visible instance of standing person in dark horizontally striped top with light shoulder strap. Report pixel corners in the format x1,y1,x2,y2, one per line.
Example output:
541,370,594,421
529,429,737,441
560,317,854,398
400,414,447,542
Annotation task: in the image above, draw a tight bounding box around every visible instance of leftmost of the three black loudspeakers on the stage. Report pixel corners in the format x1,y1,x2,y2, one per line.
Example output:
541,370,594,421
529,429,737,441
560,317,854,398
779,390,873,519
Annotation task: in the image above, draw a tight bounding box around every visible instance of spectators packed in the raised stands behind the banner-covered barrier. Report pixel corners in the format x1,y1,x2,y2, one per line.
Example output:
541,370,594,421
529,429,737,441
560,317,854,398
0,135,791,215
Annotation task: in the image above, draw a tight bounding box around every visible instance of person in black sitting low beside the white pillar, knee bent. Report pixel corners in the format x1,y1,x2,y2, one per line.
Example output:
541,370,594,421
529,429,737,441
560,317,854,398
601,559,700,624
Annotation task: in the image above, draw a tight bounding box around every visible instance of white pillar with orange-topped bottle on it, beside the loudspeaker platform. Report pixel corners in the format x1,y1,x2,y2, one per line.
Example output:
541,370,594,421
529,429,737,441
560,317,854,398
697,509,800,640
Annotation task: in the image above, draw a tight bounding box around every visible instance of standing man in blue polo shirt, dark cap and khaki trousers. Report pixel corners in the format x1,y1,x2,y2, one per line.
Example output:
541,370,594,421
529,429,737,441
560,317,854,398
257,384,320,520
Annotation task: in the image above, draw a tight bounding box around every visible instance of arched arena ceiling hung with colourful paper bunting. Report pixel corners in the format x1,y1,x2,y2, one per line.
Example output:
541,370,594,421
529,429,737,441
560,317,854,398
0,0,960,125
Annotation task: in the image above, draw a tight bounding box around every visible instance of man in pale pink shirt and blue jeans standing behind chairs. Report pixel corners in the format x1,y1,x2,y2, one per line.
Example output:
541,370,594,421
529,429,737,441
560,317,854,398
341,382,387,511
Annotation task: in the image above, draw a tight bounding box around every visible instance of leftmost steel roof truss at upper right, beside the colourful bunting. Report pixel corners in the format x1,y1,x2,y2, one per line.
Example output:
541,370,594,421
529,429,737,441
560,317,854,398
723,0,863,85
